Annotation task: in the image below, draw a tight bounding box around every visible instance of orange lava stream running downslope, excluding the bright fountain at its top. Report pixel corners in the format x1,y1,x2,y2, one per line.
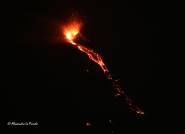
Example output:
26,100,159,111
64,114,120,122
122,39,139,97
76,44,144,114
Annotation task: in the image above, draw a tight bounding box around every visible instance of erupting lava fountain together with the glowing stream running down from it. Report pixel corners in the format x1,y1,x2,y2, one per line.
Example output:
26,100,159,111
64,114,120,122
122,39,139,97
63,13,144,114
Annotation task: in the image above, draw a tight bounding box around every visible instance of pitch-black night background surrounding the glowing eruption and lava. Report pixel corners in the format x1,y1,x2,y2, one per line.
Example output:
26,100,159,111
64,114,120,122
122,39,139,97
0,0,180,133
